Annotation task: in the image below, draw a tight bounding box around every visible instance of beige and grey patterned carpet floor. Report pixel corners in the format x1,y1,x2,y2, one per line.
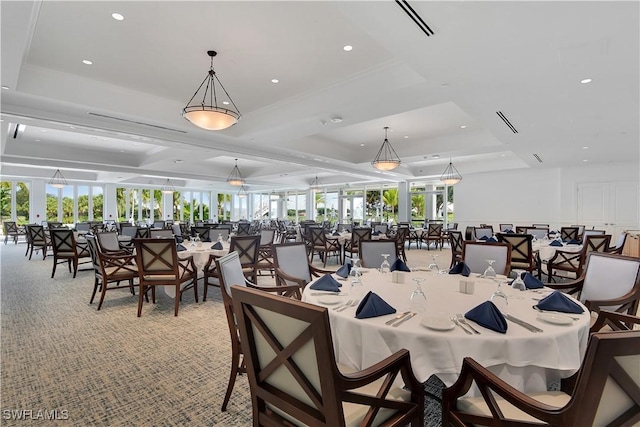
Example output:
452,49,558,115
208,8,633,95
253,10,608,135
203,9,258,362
0,244,446,426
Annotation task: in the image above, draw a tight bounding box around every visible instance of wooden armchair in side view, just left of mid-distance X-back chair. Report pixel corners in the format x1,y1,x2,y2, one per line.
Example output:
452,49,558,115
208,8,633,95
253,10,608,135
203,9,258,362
87,235,138,310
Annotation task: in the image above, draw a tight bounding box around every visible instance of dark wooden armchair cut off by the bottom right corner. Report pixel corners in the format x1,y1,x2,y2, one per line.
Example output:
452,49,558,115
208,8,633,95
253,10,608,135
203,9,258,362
442,331,640,427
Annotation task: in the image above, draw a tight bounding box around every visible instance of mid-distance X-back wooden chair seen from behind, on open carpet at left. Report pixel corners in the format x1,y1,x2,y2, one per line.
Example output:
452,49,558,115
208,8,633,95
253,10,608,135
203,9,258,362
135,238,198,317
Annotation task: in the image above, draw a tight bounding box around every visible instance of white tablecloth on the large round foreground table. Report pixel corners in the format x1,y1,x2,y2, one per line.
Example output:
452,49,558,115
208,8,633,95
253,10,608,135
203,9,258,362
303,270,589,392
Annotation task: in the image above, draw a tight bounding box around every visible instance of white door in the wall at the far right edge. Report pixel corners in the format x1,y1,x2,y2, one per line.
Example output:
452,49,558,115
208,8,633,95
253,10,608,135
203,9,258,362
577,182,640,237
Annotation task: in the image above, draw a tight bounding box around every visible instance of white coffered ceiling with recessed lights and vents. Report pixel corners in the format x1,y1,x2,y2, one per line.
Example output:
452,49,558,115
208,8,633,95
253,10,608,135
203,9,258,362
0,0,640,191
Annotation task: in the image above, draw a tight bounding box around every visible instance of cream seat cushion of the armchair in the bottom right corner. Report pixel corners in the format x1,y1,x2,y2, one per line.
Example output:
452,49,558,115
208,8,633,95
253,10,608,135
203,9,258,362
457,391,571,422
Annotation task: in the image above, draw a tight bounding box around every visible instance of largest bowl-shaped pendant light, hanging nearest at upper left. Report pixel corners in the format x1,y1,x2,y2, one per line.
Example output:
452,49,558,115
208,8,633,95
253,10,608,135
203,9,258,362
182,50,240,130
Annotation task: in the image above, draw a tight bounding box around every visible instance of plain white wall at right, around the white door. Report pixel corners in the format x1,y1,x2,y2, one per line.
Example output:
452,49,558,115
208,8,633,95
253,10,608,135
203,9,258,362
454,162,640,234
